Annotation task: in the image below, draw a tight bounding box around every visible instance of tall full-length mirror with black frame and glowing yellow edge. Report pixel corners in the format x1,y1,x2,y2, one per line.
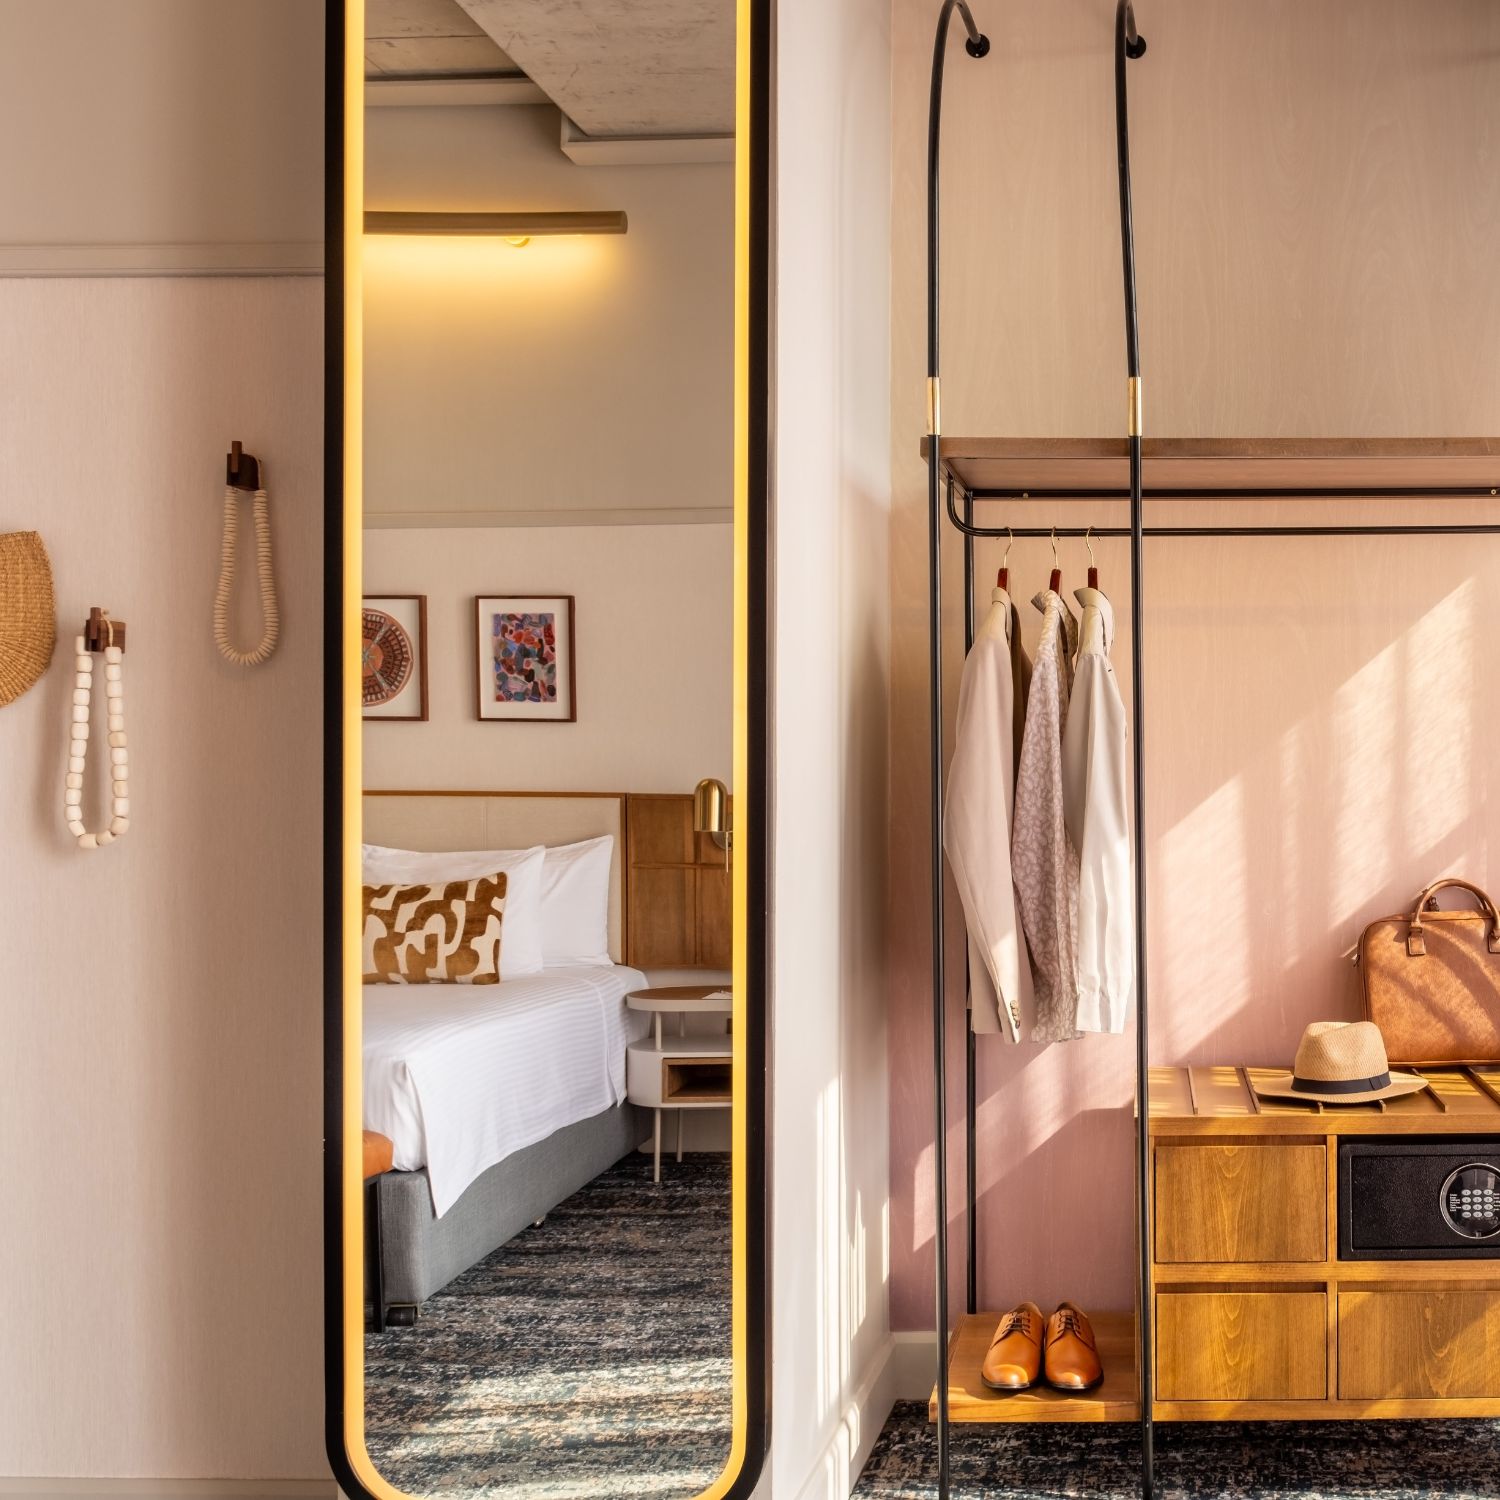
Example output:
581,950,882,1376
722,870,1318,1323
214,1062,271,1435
330,0,764,1500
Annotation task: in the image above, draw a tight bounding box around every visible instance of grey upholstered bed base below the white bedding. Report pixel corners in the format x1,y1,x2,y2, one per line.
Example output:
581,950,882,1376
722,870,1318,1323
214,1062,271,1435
377,1104,647,1307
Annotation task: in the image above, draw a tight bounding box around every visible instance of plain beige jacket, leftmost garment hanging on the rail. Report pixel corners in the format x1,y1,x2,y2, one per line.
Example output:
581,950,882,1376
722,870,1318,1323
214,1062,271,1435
944,588,1032,1041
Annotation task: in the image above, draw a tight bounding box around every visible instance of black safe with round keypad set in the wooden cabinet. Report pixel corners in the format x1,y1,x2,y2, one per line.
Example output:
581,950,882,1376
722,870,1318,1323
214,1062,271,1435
1338,1136,1500,1260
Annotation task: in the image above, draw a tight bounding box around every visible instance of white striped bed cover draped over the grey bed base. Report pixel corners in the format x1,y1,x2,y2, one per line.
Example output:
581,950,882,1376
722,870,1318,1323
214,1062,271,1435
363,965,651,1217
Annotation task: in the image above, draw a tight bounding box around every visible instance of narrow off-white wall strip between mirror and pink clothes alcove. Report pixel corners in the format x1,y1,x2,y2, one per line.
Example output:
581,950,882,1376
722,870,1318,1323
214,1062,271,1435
762,0,894,1500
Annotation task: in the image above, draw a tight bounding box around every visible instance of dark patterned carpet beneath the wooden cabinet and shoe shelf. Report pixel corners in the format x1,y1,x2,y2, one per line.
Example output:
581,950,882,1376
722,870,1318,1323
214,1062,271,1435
855,1401,1500,1500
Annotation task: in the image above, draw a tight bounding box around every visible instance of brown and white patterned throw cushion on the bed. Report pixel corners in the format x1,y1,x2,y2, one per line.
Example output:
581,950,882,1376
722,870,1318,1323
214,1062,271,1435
365,873,506,984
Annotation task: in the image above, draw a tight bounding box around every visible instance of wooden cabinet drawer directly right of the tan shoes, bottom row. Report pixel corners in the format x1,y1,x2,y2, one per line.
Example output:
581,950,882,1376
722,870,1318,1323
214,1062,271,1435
1157,1292,1328,1401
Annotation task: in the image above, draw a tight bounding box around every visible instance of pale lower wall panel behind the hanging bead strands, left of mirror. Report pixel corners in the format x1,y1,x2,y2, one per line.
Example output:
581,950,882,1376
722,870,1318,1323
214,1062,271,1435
0,281,327,1479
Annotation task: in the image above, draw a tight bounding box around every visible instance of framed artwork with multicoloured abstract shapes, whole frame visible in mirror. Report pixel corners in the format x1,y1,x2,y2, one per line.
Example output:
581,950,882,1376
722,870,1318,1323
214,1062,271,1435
474,594,578,723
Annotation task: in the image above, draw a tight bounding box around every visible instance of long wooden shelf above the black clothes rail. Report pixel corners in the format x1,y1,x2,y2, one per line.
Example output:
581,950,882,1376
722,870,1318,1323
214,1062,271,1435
923,437,1500,495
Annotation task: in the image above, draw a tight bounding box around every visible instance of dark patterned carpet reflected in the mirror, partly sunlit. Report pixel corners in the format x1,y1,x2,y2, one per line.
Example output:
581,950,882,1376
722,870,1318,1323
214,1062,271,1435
365,1155,731,1500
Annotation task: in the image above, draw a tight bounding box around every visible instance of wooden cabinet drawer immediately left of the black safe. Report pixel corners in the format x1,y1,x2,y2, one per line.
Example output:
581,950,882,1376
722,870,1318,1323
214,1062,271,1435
1155,1145,1328,1265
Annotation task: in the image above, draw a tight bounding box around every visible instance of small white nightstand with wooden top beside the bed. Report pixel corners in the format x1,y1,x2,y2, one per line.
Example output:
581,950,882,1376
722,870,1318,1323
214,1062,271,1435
626,986,735,1182
